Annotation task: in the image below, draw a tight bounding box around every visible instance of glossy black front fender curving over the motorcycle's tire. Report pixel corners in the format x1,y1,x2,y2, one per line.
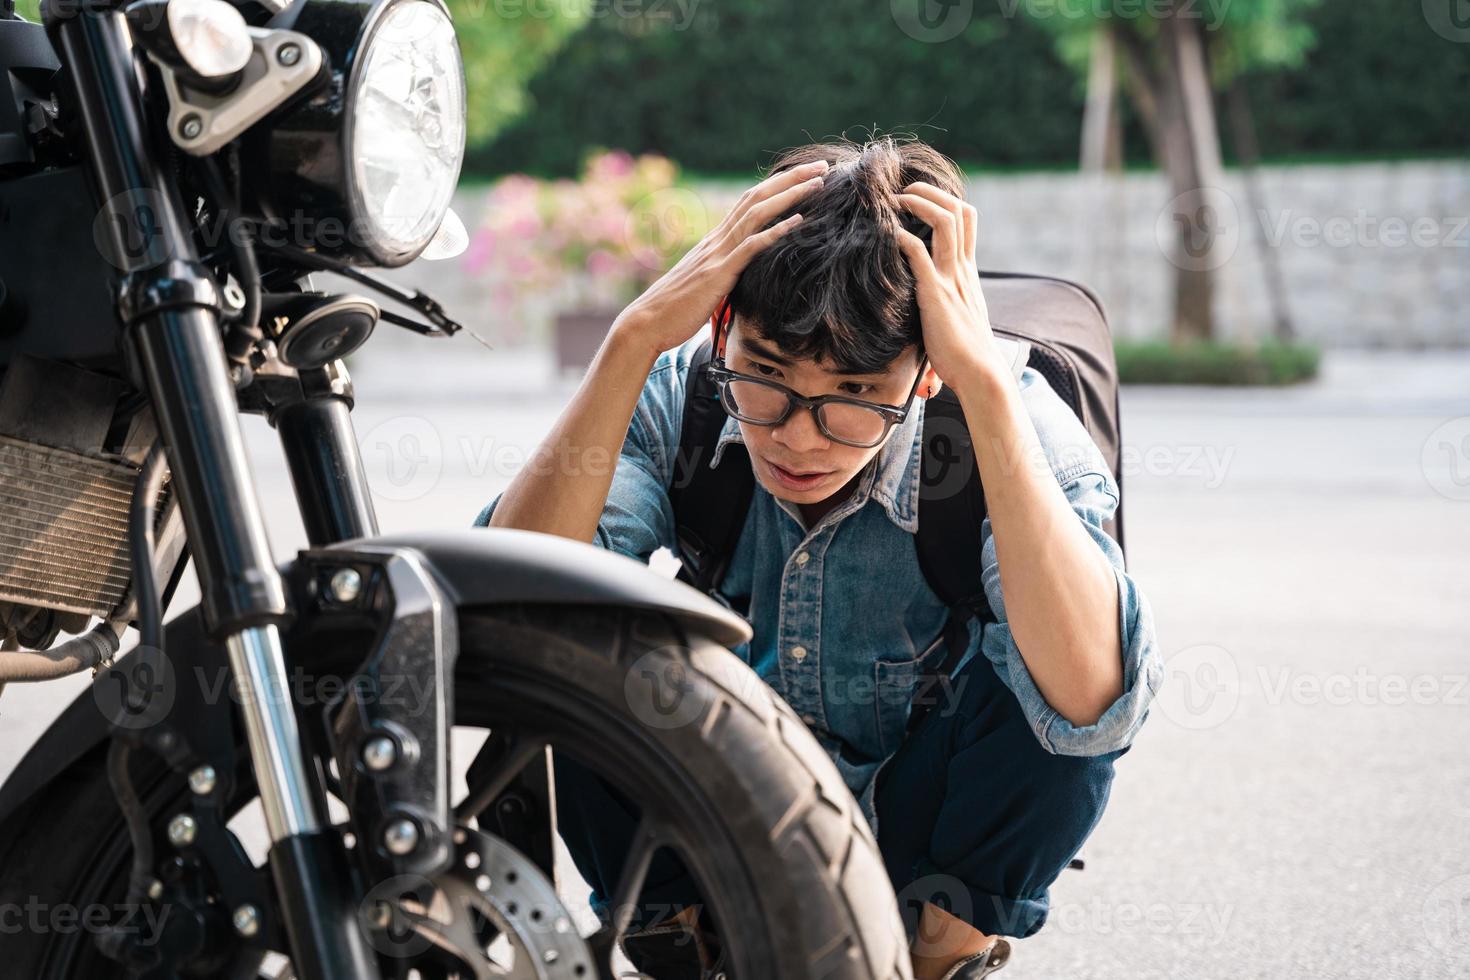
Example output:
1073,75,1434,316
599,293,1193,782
0,527,751,823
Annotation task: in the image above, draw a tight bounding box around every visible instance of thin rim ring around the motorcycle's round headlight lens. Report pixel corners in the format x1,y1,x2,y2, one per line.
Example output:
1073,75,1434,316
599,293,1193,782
340,0,467,267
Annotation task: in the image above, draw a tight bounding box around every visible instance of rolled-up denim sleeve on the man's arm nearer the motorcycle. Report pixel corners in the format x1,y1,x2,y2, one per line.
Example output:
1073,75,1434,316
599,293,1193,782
475,350,685,563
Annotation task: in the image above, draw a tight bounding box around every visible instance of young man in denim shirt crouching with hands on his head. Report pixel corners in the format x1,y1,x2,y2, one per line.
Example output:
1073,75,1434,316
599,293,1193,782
479,138,1161,980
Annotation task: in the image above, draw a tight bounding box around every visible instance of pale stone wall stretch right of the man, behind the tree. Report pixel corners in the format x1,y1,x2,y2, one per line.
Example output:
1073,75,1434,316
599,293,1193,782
970,162,1470,348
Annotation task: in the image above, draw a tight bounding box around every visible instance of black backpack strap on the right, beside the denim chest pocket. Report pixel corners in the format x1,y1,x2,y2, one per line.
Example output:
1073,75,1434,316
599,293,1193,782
908,386,995,732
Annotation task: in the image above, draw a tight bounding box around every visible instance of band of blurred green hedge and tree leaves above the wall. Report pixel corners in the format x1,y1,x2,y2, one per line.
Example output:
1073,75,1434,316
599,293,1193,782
16,0,1470,176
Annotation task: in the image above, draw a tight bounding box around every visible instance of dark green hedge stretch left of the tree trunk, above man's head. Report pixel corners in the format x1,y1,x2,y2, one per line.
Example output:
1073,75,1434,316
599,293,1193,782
467,0,1082,175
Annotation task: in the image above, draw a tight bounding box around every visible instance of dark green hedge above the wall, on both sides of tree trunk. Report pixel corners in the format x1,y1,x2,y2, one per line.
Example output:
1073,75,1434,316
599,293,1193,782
466,0,1470,175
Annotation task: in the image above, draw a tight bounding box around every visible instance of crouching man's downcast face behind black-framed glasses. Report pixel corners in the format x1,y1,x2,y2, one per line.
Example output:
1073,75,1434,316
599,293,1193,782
725,317,923,504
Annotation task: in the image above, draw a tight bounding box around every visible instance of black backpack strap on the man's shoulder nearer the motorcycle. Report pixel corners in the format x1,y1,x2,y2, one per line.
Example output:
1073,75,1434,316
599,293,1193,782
669,339,756,592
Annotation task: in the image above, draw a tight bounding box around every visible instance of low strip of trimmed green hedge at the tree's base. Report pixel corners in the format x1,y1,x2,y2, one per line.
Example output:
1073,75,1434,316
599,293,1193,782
1114,341,1322,385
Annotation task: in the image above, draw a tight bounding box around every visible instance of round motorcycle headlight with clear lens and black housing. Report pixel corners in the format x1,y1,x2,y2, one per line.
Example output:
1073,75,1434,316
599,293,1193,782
245,0,465,267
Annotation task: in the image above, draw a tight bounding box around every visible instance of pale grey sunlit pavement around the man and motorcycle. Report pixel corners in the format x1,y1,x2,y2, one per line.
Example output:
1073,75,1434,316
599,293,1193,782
0,328,1470,980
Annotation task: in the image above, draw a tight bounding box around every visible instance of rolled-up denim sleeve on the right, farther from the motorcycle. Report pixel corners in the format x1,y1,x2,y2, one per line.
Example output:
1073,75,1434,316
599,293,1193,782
980,372,1164,755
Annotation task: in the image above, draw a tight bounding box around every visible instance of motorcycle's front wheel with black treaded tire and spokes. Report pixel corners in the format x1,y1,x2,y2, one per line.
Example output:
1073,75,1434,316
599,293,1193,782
0,605,910,980
